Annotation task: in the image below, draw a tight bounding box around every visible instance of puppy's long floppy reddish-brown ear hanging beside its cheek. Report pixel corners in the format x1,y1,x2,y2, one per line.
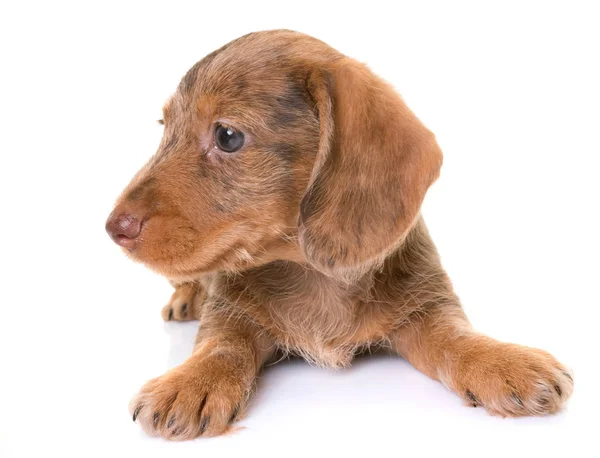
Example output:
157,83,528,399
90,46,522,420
298,58,442,281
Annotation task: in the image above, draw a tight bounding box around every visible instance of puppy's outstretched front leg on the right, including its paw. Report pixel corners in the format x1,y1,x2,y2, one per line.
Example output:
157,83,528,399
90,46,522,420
392,303,573,417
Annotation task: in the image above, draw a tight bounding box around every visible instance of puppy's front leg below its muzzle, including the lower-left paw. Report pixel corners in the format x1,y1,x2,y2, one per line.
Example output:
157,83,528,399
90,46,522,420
130,302,275,440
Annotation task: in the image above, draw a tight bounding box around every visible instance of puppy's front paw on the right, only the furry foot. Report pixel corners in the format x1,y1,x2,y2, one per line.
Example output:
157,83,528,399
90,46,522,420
455,343,573,417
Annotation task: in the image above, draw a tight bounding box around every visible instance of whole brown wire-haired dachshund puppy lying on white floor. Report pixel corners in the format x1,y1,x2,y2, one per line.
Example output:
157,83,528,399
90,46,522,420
107,31,573,439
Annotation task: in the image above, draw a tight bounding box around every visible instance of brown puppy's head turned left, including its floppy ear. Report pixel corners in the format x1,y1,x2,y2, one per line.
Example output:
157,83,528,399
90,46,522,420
106,31,441,281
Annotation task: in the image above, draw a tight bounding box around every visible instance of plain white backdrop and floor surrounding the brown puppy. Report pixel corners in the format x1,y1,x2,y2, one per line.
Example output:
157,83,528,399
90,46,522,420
0,1,600,458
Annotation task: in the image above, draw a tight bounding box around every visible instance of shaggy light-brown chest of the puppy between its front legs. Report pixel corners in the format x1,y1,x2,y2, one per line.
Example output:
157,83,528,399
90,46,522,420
224,263,389,367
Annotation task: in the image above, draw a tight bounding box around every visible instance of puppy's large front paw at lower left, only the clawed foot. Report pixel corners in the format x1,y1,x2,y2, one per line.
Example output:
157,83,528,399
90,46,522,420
129,355,253,440
